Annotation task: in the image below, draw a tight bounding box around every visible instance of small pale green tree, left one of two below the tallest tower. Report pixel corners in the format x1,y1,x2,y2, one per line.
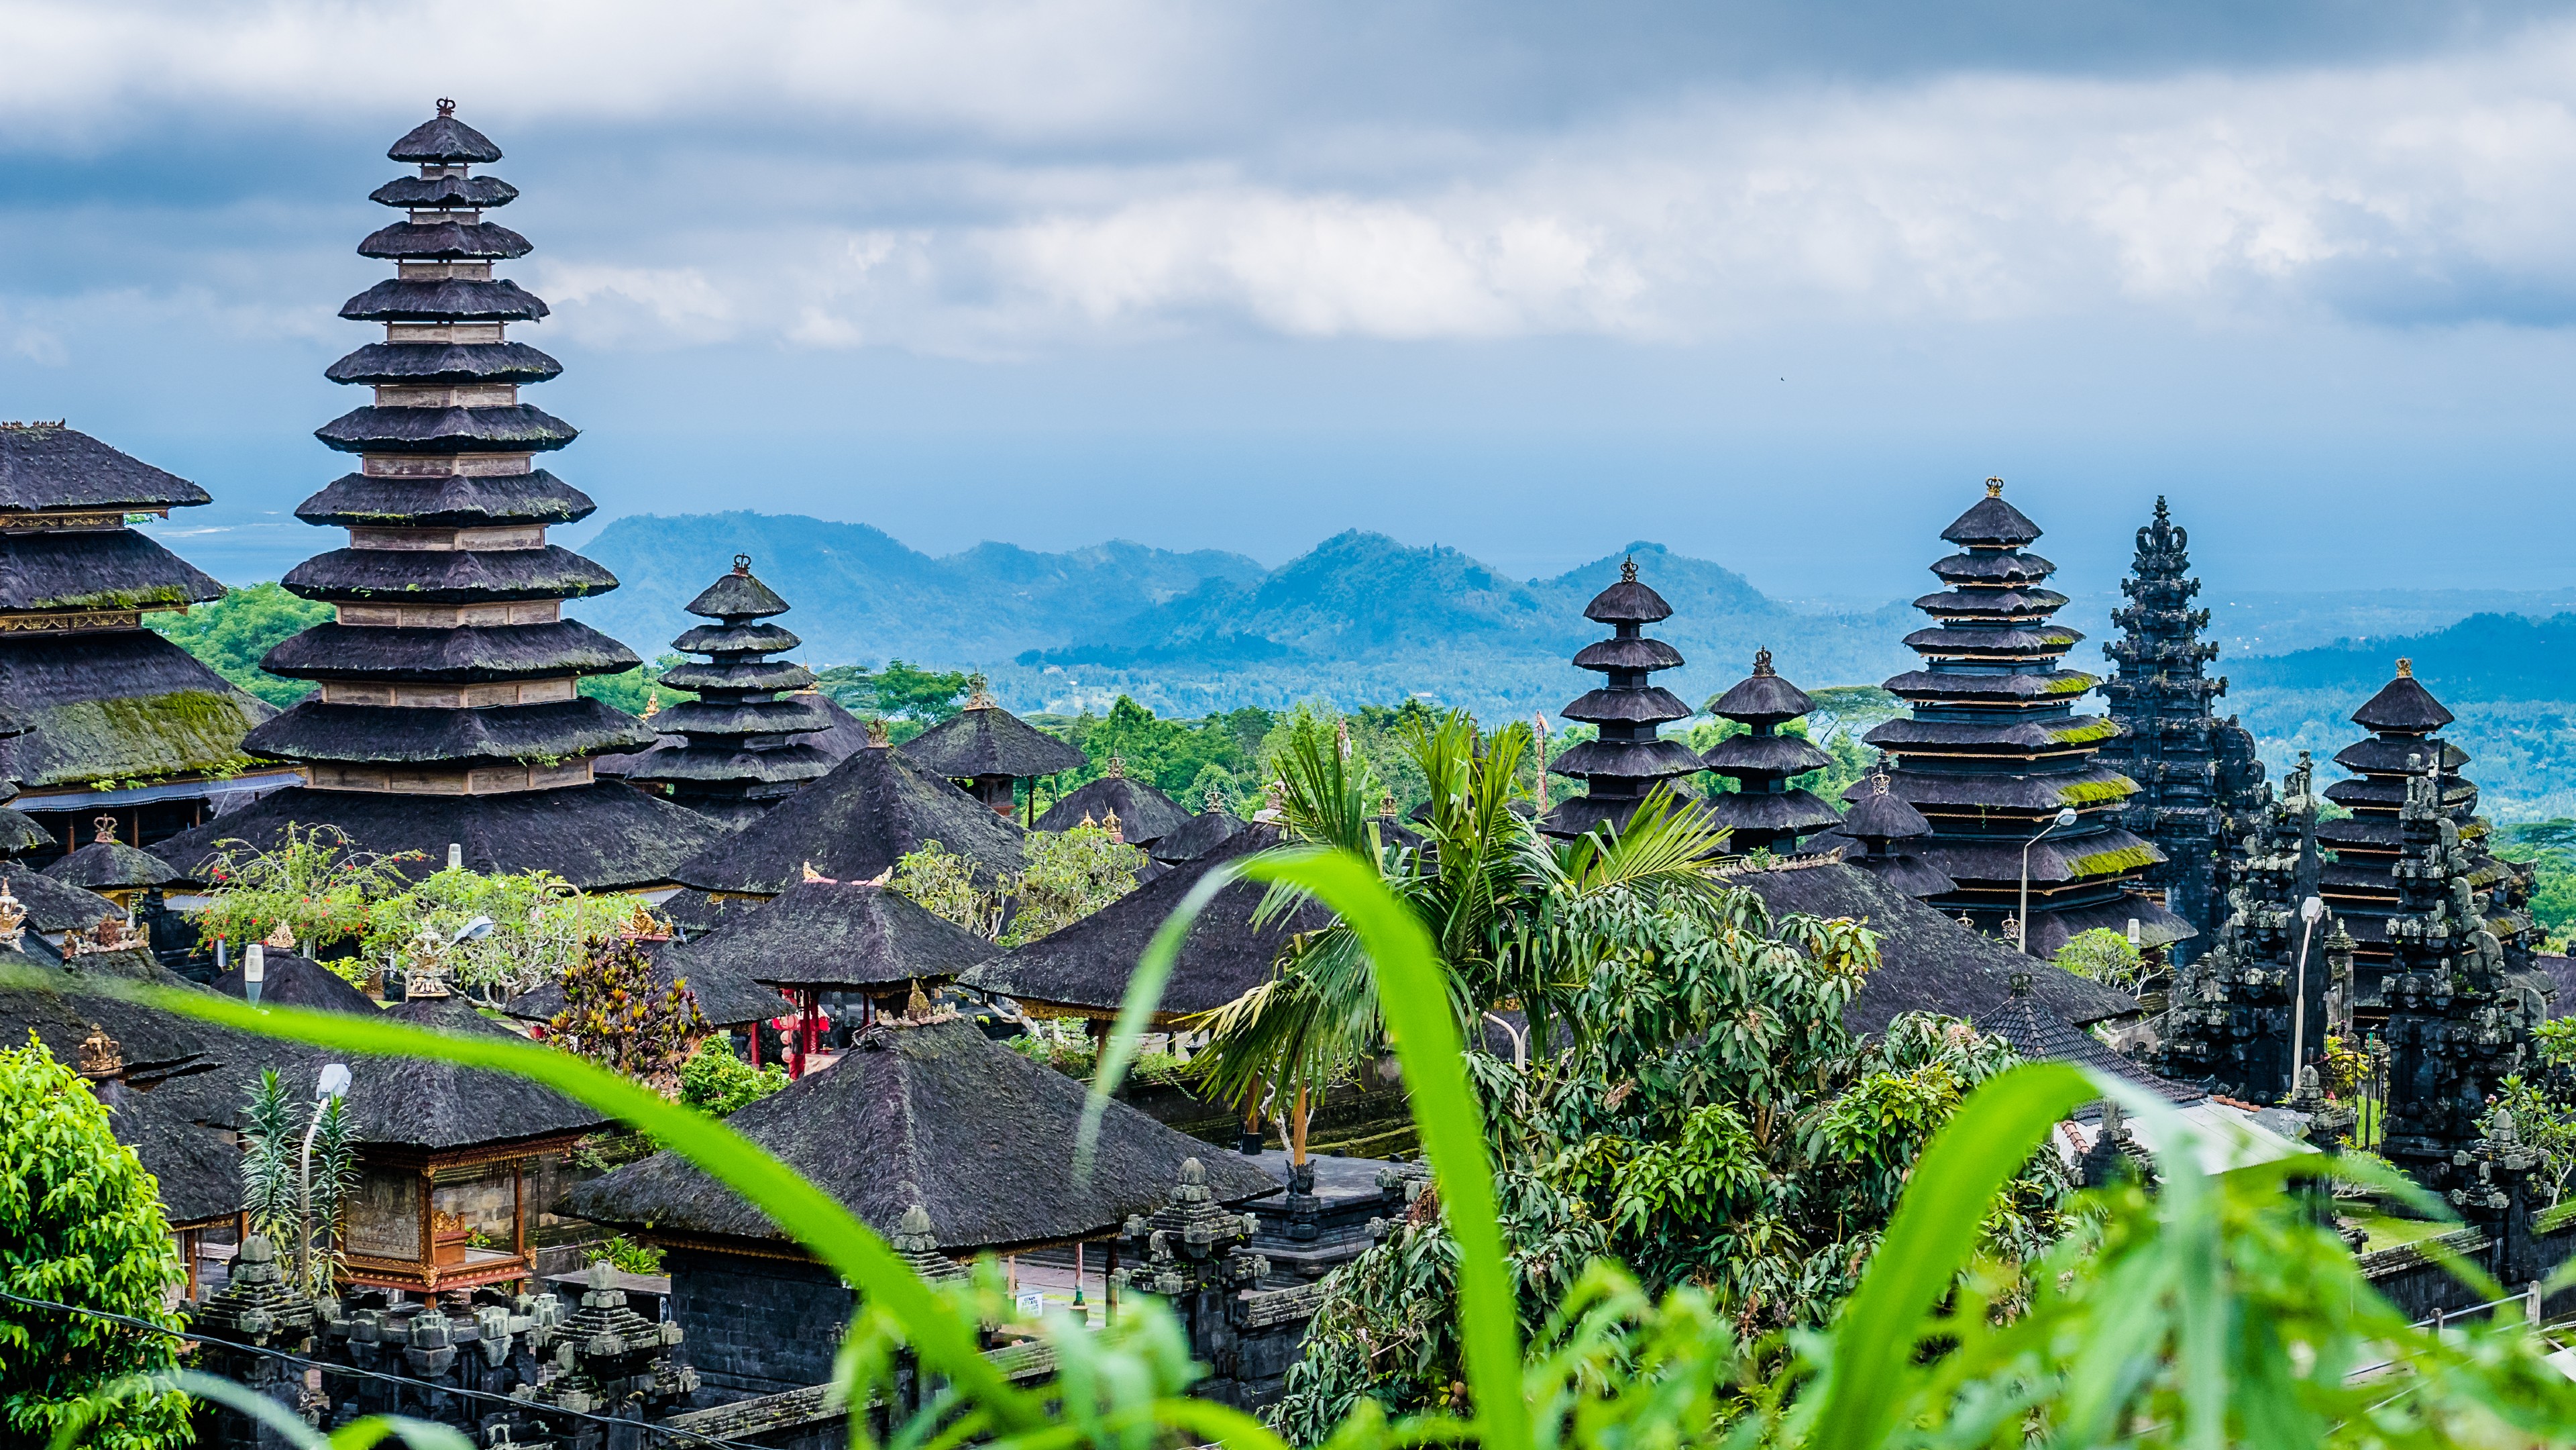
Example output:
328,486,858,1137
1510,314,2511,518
196,821,420,979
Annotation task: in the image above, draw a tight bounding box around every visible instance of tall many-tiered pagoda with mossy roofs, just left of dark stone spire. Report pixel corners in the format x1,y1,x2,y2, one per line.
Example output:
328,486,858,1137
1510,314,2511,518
1844,479,2192,958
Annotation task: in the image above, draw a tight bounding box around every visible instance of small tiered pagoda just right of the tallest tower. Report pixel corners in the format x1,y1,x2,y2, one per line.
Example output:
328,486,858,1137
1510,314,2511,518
626,554,835,827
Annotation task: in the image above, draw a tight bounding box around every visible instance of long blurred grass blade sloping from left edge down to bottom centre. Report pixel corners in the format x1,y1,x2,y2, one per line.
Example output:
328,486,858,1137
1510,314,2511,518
105,986,1046,1429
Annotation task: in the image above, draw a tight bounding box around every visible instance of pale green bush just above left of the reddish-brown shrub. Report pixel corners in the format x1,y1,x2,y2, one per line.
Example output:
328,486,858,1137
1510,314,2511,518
363,866,654,1007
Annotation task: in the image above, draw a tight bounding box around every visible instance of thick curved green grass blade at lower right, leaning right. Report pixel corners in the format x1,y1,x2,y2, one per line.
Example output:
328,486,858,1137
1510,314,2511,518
1803,1061,2102,1450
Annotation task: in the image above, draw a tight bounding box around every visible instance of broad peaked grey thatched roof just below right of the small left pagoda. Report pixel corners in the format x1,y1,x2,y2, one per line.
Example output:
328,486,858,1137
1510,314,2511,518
678,747,1020,896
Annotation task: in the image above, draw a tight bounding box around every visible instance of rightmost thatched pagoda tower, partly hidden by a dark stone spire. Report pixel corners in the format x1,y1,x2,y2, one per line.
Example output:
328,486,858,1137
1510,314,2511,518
2316,660,2532,1023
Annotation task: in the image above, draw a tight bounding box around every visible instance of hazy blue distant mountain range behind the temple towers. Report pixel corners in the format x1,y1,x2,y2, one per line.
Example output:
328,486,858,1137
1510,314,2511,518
574,513,2576,819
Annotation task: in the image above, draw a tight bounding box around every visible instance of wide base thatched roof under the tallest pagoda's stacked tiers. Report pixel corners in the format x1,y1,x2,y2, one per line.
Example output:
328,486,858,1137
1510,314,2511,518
152,783,724,891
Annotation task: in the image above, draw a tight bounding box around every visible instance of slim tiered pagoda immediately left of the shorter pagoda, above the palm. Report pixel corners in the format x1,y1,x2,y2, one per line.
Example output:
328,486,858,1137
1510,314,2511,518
1538,559,1700,837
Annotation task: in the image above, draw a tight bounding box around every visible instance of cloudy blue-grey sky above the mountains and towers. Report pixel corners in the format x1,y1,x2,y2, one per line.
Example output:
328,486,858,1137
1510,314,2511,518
0,0,2576,600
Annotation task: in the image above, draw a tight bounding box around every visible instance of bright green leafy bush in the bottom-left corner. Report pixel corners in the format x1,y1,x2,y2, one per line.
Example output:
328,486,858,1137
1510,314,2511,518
0,1035,191,1450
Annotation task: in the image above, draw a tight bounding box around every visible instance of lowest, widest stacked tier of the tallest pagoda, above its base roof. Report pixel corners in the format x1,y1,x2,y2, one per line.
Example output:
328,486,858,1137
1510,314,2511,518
242,695,659,768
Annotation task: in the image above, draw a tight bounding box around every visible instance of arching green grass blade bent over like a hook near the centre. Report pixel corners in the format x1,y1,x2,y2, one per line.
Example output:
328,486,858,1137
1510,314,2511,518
1082,847,1514,1450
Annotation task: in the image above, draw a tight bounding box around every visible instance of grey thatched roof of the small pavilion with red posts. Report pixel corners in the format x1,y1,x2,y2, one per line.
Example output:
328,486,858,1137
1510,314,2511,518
669,881,1002,992
